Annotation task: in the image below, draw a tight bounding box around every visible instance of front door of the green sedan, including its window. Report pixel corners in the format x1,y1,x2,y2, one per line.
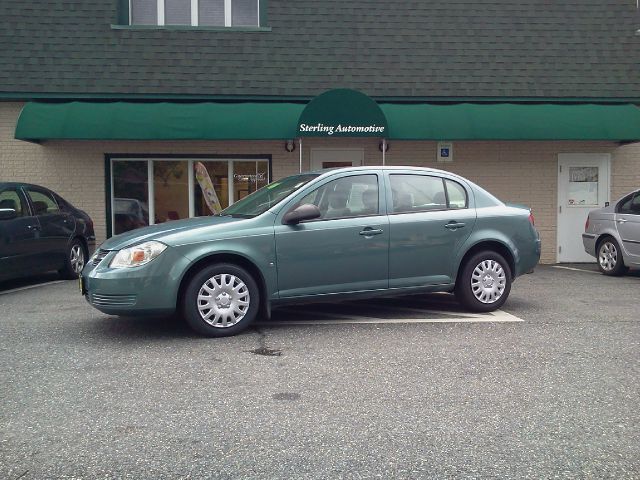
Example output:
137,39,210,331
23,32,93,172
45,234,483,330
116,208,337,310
275,171,389,298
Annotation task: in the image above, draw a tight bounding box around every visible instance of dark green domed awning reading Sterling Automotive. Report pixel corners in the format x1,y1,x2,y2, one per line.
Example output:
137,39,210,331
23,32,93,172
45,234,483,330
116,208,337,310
298,89,389,138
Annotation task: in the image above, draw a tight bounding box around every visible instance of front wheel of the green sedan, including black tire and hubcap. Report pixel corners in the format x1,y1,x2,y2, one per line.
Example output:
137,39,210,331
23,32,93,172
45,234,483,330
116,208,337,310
182,263,260,337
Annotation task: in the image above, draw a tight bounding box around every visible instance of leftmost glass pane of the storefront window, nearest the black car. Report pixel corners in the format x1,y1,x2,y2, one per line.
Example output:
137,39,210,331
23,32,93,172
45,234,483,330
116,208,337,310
111,160,149,235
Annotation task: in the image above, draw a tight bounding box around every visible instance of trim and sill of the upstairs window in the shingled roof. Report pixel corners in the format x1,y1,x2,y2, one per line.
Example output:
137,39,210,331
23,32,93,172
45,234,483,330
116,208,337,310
124,0,271,27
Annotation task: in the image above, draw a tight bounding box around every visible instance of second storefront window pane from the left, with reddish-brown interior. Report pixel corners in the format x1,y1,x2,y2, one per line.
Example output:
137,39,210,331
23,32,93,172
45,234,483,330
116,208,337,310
153,160,189,223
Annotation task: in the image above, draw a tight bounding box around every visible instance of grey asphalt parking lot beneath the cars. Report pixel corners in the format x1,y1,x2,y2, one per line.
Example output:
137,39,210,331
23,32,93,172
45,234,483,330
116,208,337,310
0,265,640,479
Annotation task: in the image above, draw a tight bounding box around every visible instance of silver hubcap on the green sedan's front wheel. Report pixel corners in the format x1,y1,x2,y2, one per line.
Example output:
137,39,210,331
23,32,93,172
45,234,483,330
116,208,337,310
198,273,251,328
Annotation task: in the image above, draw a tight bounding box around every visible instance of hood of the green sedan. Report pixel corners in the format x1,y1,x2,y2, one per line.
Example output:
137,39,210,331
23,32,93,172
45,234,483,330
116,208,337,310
100,217,246,250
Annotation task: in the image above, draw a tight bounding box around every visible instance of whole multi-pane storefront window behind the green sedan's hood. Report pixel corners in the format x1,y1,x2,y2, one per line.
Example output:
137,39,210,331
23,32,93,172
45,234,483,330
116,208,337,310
111,158,269,235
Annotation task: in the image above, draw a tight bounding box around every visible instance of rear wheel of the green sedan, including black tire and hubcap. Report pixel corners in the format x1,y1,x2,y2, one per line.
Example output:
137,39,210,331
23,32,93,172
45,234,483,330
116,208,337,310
455,250,511,312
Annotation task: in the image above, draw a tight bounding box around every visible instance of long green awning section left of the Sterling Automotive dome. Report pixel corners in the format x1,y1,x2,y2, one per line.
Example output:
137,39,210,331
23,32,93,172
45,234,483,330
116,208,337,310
15,102,305,141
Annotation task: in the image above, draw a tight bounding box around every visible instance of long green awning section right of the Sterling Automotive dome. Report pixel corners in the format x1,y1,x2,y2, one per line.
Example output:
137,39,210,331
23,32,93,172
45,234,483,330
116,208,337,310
380,103,640,141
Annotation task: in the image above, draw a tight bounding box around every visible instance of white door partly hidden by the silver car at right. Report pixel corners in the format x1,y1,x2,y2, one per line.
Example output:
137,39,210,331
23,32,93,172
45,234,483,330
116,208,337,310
557,153,611,262
